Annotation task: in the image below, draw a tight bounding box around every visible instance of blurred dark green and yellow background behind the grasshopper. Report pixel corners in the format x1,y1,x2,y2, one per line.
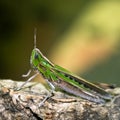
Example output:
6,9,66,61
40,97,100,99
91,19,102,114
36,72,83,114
0,0,120,85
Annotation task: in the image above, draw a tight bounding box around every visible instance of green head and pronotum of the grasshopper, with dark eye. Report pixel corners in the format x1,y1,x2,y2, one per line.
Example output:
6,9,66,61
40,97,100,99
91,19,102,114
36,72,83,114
30,48,53,69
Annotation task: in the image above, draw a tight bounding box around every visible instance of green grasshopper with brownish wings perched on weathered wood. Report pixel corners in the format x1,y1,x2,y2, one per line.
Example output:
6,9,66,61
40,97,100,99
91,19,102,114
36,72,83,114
20,29,111,103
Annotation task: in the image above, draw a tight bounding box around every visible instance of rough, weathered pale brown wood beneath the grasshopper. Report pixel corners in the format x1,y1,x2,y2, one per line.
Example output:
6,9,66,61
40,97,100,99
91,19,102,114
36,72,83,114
0,80,120,120
